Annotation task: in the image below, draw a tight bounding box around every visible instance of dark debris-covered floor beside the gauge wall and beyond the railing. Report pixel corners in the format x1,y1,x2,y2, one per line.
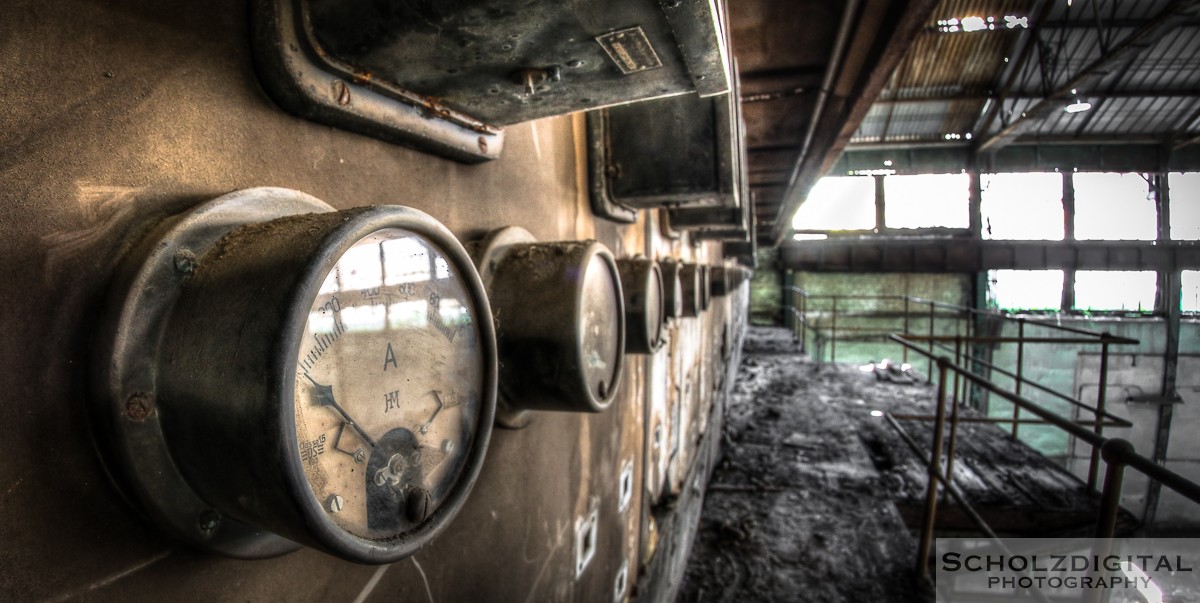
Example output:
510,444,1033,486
678,328,1130,603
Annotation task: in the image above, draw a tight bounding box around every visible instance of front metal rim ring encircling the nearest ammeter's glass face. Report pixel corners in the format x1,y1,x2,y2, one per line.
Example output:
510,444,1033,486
276,205,498,563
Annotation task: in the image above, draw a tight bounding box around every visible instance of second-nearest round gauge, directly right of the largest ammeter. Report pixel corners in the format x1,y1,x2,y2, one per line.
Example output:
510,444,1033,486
473,227,625,428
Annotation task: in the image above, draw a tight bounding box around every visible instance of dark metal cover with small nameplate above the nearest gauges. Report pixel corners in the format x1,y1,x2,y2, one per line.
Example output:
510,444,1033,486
304,0,728,126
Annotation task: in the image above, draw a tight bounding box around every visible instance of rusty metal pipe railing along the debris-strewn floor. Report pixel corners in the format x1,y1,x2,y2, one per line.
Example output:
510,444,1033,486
790,287,1200,596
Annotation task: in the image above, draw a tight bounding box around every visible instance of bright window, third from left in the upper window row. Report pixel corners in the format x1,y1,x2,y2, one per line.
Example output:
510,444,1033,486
979,172,1063,240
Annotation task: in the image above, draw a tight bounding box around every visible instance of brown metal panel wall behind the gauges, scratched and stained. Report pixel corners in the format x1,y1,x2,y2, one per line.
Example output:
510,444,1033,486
0,0,745,601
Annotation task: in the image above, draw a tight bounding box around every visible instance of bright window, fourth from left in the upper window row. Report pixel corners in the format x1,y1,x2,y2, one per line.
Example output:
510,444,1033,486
1075,172,1158,240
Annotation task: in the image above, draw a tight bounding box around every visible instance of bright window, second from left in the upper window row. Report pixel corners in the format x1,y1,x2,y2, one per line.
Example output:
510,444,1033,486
883,174,971,228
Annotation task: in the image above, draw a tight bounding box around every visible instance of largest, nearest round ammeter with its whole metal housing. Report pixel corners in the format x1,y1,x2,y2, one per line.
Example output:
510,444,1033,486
92,189,497,563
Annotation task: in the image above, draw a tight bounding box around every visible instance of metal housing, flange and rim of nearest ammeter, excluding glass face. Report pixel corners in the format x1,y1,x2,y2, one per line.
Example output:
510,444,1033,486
92,189,498,563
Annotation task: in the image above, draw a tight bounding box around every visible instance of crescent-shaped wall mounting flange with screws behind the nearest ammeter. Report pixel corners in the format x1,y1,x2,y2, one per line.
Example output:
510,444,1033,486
91,187,334,559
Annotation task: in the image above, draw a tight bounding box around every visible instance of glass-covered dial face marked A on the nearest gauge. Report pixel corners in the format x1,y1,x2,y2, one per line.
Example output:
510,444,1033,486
295,228,486,541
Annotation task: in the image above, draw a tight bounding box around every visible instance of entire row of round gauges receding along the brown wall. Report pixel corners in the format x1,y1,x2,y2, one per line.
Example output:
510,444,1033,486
94,189,744,563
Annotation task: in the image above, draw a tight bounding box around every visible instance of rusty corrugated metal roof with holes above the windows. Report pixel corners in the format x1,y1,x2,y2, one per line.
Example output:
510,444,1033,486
851,0,1200,145
